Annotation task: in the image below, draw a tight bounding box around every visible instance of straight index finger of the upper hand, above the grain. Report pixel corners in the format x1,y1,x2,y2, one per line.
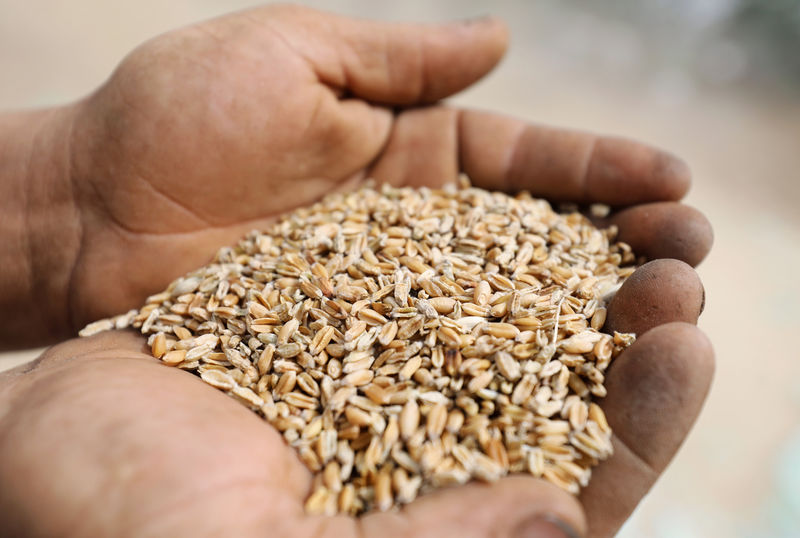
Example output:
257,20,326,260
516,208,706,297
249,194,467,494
459,110,690,206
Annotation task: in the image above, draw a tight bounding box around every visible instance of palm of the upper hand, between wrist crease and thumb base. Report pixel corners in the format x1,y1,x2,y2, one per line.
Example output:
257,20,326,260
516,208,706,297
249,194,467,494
69,10,468,321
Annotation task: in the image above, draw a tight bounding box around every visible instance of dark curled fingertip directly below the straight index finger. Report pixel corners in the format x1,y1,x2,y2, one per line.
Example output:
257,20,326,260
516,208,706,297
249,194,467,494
604,202,714,266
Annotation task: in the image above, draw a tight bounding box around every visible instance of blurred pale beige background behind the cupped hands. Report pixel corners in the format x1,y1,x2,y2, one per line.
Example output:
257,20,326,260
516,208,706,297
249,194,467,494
0,0,800,538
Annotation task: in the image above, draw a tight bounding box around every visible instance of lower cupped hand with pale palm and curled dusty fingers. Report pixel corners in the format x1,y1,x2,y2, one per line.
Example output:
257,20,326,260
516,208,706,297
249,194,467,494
0,260,713,538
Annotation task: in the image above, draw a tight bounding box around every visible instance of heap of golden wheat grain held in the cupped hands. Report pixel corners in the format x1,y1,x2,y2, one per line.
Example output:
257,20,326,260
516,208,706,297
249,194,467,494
82,181,634,514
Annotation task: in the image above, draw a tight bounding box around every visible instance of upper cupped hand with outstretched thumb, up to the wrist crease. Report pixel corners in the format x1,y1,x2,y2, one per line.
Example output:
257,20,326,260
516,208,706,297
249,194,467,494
68,6,710,330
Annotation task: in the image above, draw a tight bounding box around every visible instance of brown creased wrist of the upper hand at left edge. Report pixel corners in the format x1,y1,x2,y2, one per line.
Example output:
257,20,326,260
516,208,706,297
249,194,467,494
0,105,81,348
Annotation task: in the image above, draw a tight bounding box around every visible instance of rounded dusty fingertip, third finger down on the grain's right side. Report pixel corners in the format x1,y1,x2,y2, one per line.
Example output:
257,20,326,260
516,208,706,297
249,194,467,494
604,258,705,335
